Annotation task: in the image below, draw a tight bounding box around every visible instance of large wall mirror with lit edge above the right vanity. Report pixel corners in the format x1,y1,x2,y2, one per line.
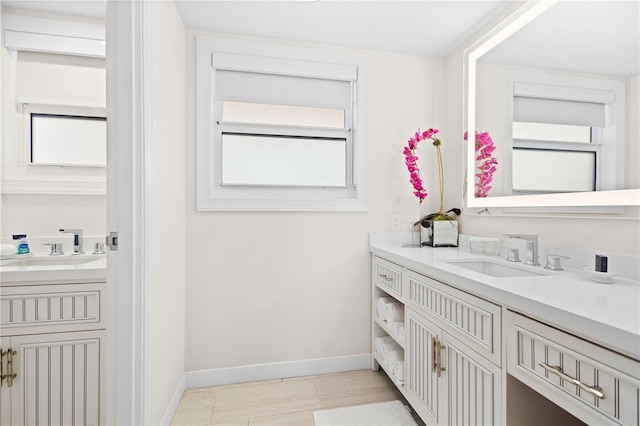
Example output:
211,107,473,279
465,1,640,207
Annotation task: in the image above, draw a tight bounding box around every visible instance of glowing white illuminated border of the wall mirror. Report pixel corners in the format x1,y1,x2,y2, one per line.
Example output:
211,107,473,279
464,0,640,208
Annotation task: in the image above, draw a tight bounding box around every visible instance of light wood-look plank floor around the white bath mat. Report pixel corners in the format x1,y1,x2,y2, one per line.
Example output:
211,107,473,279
172,370,422,426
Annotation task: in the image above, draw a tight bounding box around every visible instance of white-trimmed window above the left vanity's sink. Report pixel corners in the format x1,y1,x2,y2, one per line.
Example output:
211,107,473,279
0,14,106,195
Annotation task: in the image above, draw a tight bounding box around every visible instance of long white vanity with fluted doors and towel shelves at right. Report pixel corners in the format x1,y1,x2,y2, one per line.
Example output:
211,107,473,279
370,234,640,425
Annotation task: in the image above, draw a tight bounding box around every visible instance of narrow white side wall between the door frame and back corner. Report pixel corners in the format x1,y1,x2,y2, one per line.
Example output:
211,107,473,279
148,2,187,424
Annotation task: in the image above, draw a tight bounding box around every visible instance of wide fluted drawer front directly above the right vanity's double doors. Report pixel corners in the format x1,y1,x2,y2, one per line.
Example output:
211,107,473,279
405,271,502,366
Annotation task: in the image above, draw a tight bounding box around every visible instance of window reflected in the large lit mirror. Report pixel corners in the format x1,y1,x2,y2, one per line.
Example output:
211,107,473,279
505,72,624,194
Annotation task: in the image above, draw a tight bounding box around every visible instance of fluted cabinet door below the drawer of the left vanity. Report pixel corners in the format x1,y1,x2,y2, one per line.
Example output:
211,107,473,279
3,331,104,425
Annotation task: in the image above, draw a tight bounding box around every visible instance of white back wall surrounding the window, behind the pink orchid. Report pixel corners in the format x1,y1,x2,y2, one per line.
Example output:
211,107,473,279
185,33,442,373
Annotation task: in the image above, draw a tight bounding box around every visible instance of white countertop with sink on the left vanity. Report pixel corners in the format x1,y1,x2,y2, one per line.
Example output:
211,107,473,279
0,255,107,287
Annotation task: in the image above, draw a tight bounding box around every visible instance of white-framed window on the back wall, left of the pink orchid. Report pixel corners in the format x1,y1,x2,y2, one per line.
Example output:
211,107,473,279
197,37,367,211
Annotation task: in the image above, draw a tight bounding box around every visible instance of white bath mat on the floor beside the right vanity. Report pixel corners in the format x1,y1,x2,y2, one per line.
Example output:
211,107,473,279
313,401,417,426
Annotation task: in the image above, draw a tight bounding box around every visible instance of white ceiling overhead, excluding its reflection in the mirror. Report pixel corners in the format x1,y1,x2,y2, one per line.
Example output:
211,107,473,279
2,0,509,56
